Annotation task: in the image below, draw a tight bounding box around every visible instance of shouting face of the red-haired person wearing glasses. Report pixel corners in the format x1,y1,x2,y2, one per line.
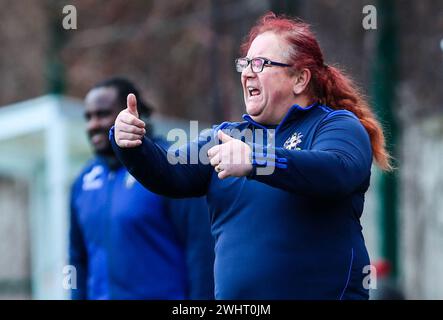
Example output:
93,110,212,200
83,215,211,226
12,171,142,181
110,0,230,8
241,32,295,124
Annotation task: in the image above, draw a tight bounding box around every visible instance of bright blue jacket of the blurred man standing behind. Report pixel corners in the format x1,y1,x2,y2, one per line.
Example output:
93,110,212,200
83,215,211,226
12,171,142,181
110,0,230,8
69,157,214,299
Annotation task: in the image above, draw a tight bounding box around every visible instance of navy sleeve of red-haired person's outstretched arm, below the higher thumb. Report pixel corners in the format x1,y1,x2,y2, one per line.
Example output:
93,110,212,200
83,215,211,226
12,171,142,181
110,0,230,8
110,127,212,198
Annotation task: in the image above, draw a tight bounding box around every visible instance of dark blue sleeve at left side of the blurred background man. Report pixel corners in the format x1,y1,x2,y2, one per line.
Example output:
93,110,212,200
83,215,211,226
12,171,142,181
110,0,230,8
69,182,88,300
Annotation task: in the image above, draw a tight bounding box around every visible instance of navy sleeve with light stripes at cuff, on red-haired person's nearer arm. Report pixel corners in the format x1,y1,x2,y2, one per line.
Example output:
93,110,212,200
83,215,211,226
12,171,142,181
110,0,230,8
248,111,372,197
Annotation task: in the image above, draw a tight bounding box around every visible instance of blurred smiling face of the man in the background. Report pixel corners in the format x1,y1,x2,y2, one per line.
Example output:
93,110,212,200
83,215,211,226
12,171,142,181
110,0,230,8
85,87,122,155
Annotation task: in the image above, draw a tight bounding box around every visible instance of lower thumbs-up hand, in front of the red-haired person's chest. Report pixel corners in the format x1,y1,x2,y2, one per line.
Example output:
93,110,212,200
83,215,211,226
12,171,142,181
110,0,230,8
208,130,252,179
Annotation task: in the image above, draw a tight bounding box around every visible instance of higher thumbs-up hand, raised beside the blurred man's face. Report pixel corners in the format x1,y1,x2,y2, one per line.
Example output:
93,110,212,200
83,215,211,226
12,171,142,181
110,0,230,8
114,93,146,148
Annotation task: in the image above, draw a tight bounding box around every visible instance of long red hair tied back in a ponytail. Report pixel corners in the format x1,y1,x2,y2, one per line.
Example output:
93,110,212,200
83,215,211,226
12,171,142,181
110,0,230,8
241,12,392,170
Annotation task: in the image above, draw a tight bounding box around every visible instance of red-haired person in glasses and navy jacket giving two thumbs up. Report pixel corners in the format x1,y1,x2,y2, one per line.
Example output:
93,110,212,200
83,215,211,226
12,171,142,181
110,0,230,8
111,13,390,299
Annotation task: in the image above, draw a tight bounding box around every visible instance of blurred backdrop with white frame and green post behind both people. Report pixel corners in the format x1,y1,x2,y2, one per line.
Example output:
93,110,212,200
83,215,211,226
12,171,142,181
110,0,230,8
0,0,443,299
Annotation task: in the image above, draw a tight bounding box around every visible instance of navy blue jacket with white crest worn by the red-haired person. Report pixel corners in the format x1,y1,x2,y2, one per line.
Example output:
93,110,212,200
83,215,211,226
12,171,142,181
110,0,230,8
111,104,372,299
